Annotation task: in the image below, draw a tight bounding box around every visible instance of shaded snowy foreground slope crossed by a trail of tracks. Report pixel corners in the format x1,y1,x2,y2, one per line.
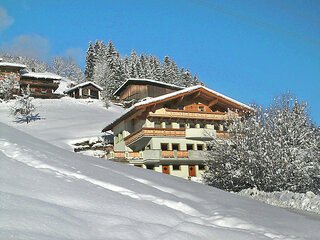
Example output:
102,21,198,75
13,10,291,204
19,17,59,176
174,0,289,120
0,123,320,240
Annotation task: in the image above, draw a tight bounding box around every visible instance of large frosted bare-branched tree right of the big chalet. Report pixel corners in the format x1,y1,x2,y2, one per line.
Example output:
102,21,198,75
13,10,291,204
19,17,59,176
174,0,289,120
205,94,320,193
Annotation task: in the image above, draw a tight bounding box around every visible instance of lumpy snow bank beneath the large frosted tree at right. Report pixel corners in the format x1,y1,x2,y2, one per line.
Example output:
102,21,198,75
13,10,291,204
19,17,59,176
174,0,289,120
238,189,320,214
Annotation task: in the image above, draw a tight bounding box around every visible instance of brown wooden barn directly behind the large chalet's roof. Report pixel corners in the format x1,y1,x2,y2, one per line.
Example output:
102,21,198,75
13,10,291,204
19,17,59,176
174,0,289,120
114,78,183,101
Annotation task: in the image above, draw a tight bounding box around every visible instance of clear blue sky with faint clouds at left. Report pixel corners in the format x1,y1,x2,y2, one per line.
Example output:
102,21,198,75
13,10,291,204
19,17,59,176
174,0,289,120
0,0,320,125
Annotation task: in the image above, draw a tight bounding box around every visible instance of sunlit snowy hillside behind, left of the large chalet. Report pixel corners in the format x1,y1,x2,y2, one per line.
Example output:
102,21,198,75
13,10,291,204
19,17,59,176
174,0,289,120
0,97,124,150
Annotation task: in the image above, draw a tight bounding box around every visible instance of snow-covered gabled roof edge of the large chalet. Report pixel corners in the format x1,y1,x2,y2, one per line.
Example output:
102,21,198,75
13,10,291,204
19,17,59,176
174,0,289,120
102,85,254,131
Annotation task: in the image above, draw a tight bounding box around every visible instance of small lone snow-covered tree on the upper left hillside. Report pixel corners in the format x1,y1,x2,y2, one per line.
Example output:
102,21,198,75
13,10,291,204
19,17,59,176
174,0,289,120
11,85,36,124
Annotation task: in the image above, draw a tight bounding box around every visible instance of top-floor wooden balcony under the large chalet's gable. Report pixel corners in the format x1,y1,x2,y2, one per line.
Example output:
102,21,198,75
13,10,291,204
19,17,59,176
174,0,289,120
148,108,237,121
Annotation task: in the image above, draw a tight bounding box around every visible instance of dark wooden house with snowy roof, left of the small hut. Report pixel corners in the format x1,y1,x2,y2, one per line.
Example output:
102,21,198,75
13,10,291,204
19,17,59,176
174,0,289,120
20,72,62,98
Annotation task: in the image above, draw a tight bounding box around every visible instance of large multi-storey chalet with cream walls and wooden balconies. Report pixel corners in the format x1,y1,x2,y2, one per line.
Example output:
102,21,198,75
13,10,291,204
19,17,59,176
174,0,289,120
103,80,253,177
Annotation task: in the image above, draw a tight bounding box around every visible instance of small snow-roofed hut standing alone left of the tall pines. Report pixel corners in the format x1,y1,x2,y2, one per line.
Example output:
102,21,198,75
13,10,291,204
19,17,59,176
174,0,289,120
64,82,103,99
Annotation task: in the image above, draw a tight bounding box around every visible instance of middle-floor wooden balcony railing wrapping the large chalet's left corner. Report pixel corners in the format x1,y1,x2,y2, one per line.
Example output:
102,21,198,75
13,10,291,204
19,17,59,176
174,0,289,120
124,128,186,146
